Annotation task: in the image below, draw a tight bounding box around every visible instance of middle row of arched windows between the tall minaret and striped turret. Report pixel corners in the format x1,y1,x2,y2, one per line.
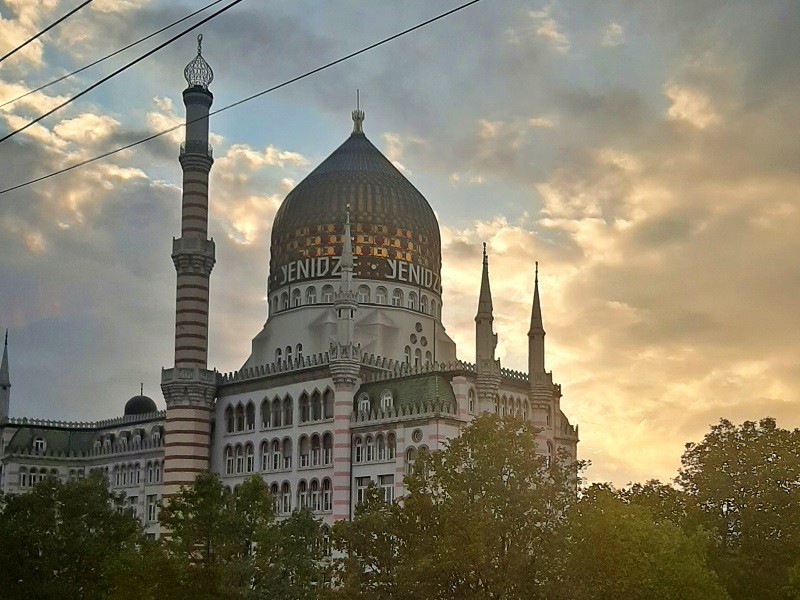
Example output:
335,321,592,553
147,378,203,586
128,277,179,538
225,432,333,475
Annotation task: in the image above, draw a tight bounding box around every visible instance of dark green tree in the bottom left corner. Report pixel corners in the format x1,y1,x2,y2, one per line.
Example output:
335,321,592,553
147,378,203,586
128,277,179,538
0,473,143,600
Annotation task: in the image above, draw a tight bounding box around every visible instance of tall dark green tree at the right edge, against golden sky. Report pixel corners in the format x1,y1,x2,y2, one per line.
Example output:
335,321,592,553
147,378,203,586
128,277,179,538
676,418,800,600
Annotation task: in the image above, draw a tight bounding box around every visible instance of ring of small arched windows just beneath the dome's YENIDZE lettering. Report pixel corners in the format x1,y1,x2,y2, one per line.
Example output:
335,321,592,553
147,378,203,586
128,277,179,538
272,285,440,317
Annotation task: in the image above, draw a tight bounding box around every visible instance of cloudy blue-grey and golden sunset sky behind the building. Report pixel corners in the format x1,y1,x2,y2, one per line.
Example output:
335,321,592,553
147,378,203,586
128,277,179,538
0,0,800,485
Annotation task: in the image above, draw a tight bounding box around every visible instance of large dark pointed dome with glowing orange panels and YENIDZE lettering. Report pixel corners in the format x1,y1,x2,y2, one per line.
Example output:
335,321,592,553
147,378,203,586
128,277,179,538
268,111,441,294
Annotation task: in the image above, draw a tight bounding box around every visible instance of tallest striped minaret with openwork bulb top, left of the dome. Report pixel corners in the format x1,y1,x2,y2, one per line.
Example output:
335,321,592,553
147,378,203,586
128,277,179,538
161,36,216,496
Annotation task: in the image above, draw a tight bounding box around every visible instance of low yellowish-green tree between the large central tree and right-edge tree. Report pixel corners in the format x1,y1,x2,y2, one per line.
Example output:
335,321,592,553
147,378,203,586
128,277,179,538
549,486,728,600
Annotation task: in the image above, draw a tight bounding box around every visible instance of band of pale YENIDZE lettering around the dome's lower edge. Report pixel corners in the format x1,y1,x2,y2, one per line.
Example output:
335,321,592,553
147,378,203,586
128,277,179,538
270,256,442,294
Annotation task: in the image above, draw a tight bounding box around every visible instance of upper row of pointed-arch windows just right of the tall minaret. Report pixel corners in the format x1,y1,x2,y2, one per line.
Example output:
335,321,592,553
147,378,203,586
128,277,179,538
225,388,333,433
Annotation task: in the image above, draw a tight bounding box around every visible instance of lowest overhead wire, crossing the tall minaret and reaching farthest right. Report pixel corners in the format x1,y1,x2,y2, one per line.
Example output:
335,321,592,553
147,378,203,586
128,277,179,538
0,0,481,195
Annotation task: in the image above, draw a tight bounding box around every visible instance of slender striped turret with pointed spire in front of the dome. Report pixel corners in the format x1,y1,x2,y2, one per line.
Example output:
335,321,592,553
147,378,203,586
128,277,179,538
330,195,364,521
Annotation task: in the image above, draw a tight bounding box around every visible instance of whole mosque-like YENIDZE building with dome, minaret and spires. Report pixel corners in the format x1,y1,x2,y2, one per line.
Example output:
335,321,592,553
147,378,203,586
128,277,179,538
0,38,578,532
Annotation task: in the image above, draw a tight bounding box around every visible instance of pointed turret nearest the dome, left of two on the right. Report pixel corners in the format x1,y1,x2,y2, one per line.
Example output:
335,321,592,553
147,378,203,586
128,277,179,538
475,242,500,411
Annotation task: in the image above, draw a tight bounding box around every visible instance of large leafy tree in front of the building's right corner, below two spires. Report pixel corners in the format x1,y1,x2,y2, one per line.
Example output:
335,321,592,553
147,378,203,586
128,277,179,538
334,415,577,599
